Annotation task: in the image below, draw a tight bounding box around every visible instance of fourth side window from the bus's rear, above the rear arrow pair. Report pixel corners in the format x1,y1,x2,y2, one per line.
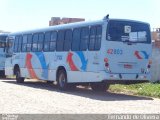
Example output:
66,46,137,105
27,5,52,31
72,28,81,51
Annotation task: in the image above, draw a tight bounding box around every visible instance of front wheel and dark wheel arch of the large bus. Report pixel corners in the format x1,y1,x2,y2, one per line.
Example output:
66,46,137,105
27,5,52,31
14,64,24,83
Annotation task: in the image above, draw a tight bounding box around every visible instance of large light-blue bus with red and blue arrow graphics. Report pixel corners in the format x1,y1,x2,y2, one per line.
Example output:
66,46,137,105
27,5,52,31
5,17,152,91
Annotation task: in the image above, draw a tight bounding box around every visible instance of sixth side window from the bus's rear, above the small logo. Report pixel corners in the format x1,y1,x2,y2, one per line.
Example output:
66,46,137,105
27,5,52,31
56,30,64,51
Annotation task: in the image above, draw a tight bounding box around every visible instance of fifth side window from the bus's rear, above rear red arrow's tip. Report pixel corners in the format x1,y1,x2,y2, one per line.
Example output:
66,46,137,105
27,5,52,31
64,30,72,51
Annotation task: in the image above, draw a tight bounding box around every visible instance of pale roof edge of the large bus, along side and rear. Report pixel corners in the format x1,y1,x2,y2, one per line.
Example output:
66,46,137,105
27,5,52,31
9,19,149,36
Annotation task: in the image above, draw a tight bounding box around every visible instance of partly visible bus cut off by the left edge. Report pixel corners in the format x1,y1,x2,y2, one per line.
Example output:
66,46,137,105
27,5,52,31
0,33,8,78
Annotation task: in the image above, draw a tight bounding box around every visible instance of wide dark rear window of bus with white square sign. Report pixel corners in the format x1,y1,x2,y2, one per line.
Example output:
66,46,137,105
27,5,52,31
107,20,151,43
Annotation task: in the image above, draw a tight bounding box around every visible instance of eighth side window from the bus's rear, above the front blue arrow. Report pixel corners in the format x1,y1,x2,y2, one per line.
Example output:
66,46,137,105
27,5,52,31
43,32,51,52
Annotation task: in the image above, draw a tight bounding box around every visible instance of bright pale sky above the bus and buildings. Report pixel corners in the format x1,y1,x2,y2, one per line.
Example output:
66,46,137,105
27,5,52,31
0,0,160,32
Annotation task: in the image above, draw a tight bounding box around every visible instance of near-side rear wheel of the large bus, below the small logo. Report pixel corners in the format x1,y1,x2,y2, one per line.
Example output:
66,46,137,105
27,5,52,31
57,69,68,90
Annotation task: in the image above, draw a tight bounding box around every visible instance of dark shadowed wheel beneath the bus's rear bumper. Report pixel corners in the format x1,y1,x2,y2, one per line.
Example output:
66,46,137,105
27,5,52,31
90,83,109,92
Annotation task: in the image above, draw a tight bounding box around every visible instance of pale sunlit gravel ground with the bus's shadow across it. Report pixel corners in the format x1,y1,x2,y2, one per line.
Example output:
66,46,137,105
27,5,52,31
0,79,160,114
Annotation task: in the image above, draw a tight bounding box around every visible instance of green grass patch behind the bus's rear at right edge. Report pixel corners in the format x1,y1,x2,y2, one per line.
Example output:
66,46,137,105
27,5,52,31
109,83,160,98
